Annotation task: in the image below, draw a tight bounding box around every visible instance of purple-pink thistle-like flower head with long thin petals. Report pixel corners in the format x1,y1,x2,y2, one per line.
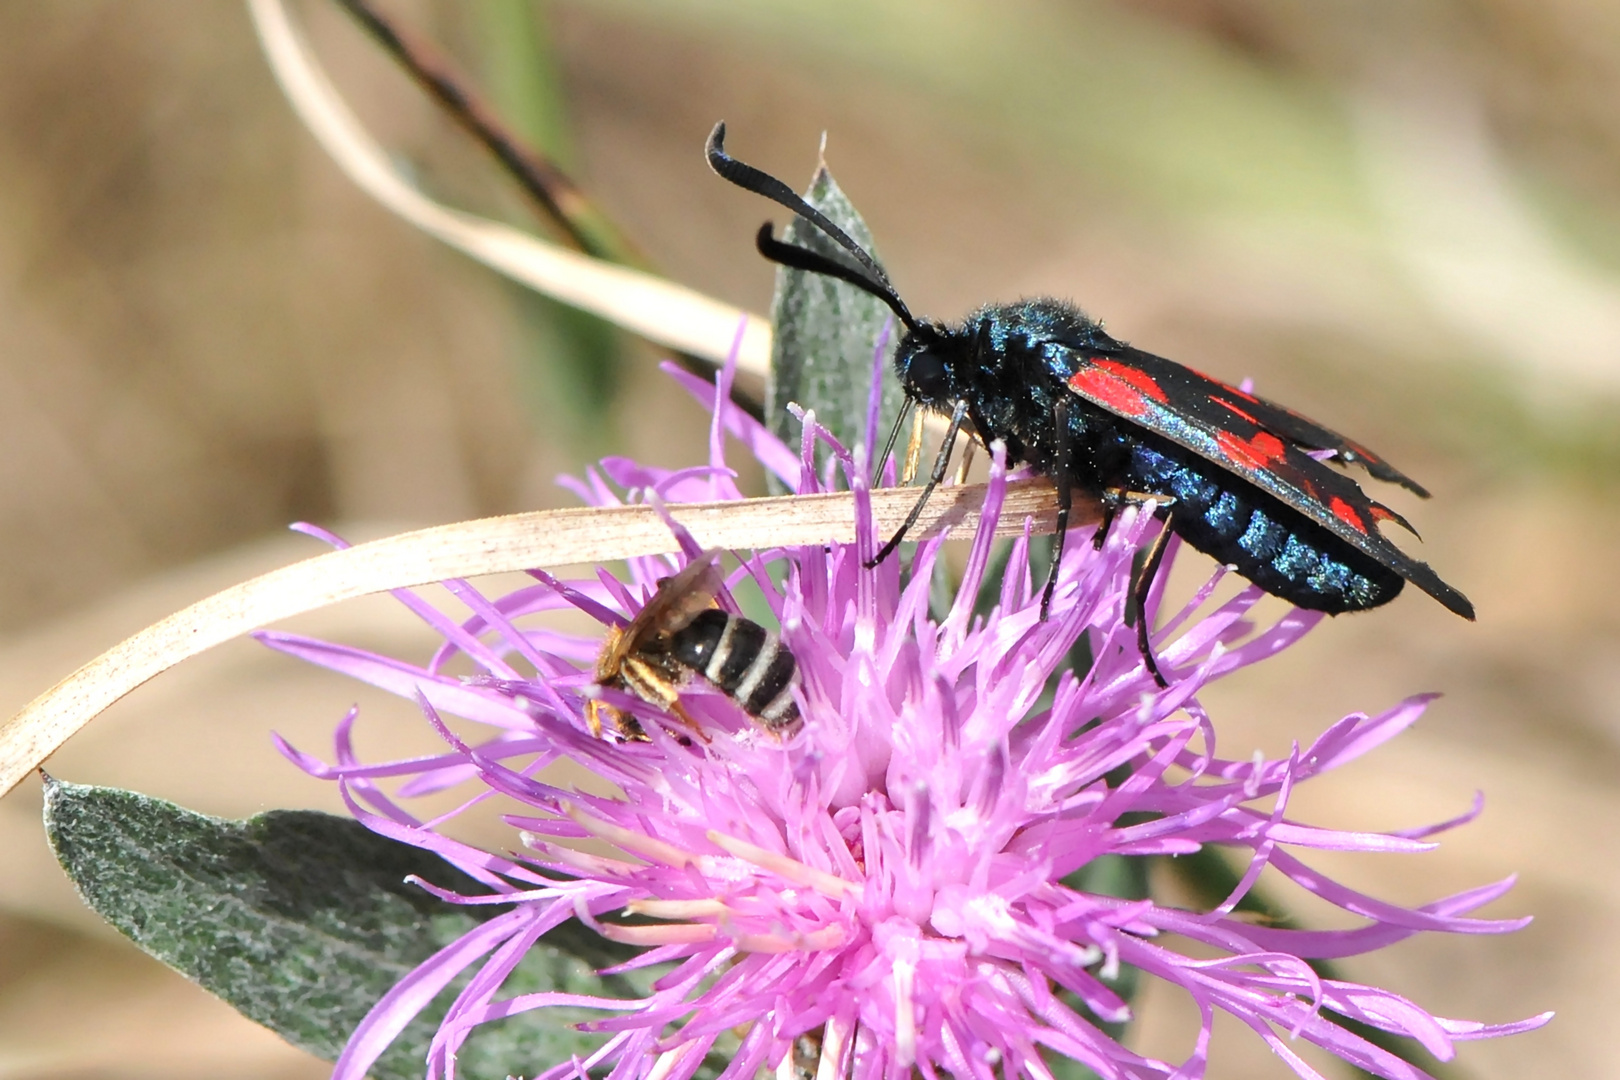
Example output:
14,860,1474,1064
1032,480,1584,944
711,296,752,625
259,354,1550,1080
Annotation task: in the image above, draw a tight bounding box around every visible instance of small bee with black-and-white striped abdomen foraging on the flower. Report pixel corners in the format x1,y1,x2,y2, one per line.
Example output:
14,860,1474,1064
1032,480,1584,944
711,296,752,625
586,551,799,738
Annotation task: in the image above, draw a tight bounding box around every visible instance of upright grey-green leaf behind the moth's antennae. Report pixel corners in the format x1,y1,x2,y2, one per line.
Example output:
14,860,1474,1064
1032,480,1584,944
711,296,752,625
765,165,904,488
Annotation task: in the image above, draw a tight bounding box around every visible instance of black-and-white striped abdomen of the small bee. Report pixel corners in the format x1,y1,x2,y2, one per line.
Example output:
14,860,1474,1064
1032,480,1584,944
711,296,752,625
669,607,799,730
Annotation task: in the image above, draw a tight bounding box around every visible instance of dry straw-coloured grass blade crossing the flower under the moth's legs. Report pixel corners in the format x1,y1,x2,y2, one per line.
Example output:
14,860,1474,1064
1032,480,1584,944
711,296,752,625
0,479,1075,795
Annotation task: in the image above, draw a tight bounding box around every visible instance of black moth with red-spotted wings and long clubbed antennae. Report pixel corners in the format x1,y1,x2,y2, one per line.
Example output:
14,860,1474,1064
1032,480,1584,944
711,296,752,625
706,125,1474,685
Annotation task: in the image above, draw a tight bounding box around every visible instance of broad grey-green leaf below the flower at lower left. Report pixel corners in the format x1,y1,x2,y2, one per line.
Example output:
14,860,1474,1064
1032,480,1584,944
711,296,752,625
45,780,656,1080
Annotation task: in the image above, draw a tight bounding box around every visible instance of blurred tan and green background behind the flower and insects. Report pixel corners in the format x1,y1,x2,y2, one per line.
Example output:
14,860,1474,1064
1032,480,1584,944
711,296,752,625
0,0,1620,1080
